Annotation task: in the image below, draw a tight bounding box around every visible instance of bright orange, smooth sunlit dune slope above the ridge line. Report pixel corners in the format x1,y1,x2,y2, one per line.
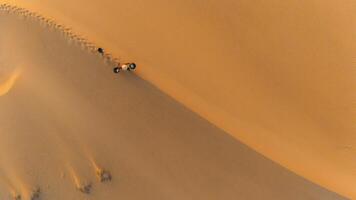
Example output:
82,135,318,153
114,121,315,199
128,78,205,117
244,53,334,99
3,0,356,198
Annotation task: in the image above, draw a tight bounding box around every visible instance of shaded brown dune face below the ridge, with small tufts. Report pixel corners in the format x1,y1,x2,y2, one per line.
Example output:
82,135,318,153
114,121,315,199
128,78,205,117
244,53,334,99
0,10,342,200
